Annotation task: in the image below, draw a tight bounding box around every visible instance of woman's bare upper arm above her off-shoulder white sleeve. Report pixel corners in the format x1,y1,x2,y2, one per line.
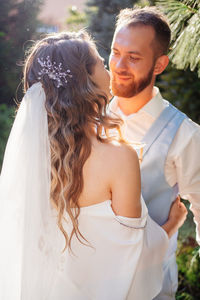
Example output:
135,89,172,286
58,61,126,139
110,145,141,218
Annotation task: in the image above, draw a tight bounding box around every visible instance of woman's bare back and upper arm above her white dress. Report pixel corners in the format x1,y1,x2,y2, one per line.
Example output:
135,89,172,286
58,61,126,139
78,138,140,217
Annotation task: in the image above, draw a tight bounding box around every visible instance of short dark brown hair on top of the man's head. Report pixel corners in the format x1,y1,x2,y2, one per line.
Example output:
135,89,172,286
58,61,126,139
116,6,171,55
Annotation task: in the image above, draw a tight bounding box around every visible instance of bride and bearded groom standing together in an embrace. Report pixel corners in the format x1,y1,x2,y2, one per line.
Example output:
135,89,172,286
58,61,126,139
0,8,200,300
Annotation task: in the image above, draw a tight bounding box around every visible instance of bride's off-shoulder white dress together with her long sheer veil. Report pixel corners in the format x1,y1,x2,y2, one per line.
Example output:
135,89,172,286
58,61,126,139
0,83,168,300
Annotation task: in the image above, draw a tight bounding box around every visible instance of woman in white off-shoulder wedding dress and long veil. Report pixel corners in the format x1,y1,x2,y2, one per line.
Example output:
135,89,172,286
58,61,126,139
0,31,187,300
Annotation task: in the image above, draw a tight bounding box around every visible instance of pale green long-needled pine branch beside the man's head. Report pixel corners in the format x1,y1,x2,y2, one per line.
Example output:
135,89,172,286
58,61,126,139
157,0,200,77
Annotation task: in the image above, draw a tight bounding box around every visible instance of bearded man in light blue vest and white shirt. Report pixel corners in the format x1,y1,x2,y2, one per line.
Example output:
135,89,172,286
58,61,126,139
109,8,200,300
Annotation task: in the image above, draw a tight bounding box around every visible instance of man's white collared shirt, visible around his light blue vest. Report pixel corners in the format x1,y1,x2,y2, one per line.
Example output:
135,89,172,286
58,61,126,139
109,87,200,244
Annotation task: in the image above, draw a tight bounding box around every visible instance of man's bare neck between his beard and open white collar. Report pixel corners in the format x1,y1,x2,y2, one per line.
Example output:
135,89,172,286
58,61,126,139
116,87,155,115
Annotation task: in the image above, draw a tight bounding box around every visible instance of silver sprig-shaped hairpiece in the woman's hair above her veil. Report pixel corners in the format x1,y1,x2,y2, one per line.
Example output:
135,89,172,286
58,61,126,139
37,56,73,88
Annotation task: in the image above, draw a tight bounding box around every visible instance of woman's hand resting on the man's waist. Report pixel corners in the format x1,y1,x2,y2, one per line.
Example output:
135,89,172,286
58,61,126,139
162,196,188,238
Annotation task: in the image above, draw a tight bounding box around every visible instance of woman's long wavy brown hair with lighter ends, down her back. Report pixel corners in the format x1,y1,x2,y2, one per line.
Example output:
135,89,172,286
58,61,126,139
24,31,121,250
